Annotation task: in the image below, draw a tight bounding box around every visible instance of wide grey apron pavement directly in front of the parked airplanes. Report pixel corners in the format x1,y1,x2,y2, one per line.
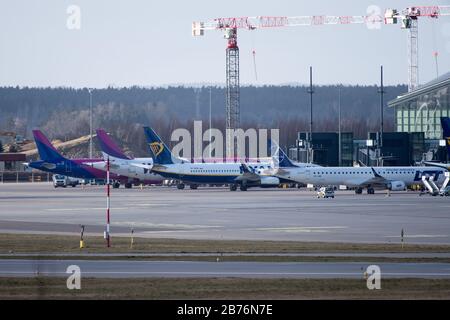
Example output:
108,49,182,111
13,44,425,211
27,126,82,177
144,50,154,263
0,183,450,244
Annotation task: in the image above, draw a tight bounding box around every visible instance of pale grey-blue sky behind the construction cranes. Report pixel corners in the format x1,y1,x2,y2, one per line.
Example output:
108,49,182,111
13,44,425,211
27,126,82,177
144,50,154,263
0,0,450,88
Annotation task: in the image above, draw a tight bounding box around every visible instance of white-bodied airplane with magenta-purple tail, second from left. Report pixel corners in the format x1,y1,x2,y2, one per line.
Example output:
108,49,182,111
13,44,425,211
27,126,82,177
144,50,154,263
91,129,164,188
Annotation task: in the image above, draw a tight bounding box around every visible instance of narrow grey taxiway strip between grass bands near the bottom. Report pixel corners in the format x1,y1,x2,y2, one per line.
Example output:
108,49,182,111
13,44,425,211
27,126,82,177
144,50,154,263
0,260,450,279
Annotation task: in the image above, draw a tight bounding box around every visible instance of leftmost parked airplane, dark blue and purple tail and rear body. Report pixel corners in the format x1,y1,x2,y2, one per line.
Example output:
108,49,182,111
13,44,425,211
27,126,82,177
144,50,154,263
27,130,128,181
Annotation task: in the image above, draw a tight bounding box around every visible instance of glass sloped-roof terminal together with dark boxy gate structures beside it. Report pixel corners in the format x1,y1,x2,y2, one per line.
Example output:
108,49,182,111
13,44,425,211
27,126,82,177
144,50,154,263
289,72,450,166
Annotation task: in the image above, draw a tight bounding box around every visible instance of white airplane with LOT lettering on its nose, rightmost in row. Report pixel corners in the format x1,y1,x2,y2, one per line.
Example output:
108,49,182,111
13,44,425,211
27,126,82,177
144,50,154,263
275,139,447,194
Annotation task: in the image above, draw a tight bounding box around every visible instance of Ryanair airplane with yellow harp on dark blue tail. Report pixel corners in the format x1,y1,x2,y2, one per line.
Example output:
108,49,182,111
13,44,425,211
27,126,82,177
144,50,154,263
144,127,296,191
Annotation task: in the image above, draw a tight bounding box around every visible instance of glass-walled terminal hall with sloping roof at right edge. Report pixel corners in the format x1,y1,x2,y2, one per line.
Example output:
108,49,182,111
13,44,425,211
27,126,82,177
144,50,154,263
388,72,450,140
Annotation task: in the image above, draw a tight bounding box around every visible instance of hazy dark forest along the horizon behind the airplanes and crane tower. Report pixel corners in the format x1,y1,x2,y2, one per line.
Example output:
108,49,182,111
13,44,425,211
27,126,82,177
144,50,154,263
0,85,407,156
